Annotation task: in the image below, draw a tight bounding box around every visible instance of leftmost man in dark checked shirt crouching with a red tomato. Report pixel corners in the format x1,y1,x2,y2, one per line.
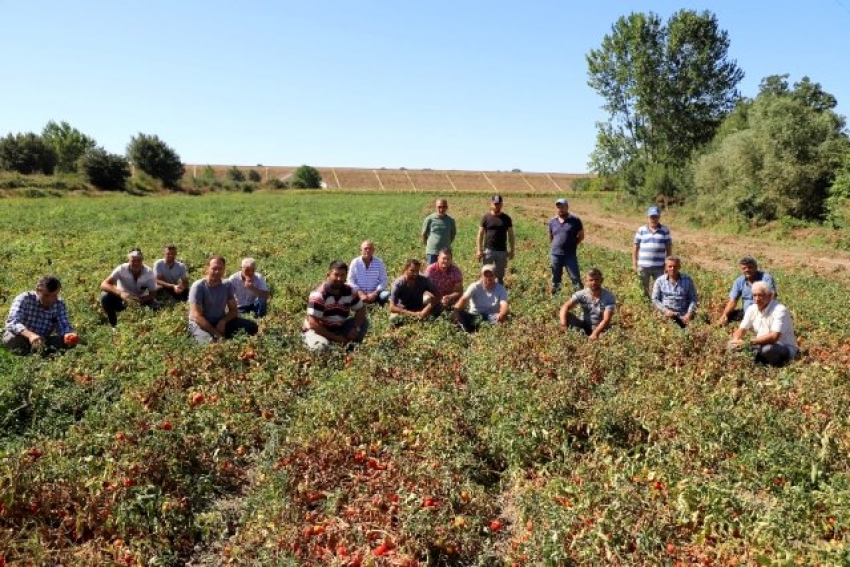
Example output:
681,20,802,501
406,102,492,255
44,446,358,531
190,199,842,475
3,276,79,354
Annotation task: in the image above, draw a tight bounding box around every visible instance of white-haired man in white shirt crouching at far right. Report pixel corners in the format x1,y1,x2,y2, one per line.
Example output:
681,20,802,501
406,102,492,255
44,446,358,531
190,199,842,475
729,281,797,366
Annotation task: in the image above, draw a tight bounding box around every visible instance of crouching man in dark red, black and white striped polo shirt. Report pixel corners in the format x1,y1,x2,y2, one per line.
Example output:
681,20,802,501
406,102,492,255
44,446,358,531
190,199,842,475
301,260,369,352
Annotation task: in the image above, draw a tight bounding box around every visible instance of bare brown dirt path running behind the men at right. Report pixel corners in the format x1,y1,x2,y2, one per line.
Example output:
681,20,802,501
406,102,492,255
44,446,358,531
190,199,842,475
521,199,850,283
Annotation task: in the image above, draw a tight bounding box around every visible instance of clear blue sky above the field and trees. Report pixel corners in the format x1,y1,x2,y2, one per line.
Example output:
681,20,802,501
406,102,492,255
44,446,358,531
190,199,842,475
0,0,850,173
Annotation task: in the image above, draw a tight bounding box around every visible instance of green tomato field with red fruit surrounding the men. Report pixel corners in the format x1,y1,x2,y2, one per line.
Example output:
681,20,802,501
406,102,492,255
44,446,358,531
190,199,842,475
0,191,850,566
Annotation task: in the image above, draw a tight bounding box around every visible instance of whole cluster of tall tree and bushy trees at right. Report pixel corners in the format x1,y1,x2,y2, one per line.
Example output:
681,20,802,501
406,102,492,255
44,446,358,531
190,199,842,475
586,10,850,226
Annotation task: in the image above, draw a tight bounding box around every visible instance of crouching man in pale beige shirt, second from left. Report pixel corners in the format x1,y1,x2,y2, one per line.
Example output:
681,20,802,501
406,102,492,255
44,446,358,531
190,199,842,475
100,248,159,327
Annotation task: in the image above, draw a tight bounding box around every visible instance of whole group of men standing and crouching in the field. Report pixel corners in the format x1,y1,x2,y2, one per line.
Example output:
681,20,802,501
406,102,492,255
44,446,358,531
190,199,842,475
3,200,797,365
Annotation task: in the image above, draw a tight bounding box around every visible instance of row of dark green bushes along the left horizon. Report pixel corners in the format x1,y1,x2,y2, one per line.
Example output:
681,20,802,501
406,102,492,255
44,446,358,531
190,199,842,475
0,124,322,191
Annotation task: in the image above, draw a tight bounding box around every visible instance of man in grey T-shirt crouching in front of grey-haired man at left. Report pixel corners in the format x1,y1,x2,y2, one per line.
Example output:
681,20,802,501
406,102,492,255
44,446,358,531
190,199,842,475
188,256,257,345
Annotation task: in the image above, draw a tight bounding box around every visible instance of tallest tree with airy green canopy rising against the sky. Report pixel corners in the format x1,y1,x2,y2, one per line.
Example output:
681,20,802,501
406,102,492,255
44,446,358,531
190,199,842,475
587,10,744,174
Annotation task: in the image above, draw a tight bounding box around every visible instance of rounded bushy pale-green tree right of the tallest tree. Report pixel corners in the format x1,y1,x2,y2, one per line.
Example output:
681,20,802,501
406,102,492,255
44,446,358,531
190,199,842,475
694,76,850,221
